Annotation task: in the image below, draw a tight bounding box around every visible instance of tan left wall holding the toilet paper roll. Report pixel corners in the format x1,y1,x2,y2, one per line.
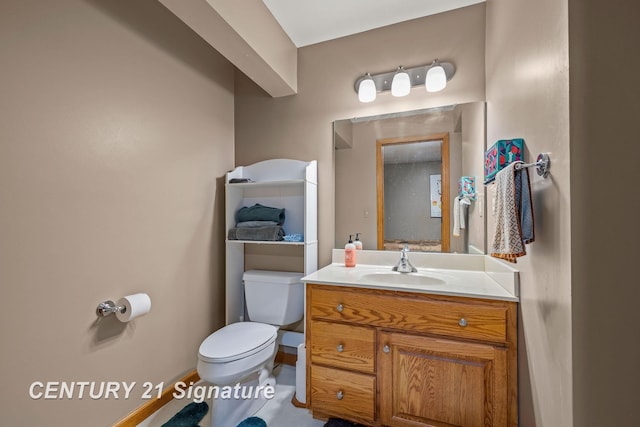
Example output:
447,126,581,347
0,0,234,427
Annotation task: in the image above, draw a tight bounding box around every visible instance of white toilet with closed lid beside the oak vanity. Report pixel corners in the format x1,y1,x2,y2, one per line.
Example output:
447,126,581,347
197,270,304,427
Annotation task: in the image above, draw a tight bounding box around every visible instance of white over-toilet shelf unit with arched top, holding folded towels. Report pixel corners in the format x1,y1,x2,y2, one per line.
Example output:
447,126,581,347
225,159,318,324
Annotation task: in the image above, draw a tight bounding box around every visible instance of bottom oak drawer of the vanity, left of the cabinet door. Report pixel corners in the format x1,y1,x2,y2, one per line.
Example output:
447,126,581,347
311,364,376,421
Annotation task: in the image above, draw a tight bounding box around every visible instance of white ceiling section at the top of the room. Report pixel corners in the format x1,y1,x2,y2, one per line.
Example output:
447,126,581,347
262,0,485,47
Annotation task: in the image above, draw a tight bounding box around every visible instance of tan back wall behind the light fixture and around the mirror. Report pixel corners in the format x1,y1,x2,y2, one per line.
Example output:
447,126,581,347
236,4,484,266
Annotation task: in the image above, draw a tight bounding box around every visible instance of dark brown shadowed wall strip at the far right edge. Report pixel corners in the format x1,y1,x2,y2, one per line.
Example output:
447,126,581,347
569,0,640,427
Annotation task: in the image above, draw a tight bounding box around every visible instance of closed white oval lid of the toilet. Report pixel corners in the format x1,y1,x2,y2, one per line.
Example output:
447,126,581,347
199,322,278,363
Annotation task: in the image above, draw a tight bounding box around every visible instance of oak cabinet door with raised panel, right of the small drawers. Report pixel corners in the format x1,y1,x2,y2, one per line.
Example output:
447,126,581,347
378,331,508,427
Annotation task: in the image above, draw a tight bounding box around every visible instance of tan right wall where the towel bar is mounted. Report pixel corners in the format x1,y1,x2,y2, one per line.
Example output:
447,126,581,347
486,0,578,427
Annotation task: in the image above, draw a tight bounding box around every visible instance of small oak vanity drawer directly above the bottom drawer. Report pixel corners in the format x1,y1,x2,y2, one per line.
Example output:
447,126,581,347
310,321,376,373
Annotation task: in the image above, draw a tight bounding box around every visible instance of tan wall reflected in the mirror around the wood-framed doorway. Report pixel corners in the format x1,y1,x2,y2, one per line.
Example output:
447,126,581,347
334,102,486,253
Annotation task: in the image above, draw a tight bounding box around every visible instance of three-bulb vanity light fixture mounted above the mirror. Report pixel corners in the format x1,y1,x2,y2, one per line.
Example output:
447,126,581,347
354,59,456,102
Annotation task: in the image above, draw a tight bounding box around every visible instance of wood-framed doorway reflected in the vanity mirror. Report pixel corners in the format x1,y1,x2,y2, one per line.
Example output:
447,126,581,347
376,133,450,252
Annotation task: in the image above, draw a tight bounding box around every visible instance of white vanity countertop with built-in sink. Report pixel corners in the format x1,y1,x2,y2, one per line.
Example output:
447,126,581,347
302,249,519,302
